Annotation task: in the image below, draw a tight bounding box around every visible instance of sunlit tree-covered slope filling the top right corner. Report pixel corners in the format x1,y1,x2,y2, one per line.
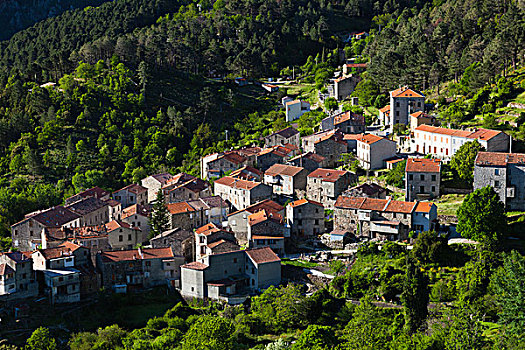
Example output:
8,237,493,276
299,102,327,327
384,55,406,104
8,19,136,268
365,0,525,93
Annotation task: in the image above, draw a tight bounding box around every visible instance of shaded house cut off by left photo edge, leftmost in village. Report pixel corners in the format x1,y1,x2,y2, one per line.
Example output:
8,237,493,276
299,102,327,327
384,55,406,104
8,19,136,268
0,252,38,301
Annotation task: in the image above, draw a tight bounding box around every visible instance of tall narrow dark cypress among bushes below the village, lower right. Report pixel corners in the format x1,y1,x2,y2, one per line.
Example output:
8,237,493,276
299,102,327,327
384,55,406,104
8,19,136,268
401,257,429,334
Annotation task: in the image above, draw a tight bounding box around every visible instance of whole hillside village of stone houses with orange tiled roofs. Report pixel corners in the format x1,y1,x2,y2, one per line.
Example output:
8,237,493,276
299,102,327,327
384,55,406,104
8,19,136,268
0,52,525,312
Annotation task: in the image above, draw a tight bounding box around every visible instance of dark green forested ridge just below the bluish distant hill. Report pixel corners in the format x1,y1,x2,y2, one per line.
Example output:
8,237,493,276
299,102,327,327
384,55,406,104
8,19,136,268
0,0,190,82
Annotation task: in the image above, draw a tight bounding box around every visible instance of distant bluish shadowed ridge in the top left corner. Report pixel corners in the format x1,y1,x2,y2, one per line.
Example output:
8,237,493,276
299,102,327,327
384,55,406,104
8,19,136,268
0,0,108,41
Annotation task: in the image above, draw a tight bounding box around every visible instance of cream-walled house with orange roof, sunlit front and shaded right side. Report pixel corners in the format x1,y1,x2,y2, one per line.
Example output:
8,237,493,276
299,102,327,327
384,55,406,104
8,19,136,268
214,176,272,210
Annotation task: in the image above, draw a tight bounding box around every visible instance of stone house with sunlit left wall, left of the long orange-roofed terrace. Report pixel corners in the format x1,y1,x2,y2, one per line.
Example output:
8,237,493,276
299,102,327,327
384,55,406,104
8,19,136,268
286,198,325,238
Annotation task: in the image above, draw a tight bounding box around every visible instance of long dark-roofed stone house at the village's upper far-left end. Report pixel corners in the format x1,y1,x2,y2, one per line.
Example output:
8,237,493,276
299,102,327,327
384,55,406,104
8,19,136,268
11,206,82,251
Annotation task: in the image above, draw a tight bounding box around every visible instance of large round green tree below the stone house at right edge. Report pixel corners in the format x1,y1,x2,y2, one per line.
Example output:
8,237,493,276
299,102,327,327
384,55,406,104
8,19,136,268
456,186,507,246
